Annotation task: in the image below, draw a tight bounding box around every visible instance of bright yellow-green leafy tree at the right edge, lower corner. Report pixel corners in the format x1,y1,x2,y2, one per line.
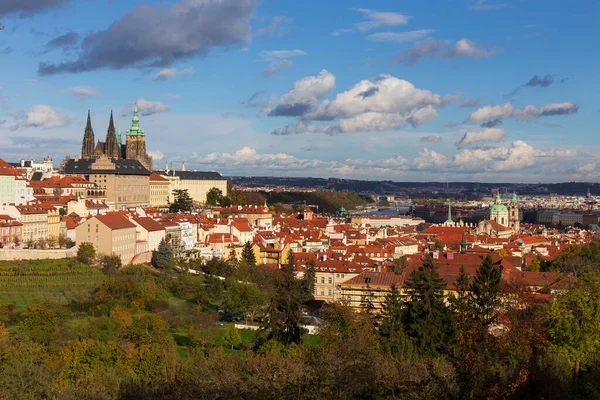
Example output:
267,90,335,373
548,275,600,378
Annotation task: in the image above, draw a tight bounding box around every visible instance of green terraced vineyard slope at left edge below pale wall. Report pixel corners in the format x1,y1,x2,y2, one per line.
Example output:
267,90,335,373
0,259,104,311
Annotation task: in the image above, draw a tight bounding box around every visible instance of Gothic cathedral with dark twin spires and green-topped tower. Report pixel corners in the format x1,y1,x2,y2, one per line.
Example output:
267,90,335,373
81,105,152,170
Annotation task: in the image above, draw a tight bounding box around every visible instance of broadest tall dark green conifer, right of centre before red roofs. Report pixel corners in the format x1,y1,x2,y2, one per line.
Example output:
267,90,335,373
402,257,456,355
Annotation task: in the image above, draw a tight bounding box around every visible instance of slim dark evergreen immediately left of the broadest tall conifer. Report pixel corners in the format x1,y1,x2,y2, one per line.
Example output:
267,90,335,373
379,284,413,358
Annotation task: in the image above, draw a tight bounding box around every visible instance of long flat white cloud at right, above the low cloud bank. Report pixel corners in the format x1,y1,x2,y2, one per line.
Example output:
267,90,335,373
468,102,579,122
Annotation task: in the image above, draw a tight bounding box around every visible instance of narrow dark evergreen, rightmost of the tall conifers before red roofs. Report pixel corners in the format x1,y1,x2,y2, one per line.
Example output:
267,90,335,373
470,256,502,327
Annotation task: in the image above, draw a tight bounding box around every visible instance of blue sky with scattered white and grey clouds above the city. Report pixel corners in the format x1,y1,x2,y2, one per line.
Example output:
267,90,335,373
0,0,600,182
